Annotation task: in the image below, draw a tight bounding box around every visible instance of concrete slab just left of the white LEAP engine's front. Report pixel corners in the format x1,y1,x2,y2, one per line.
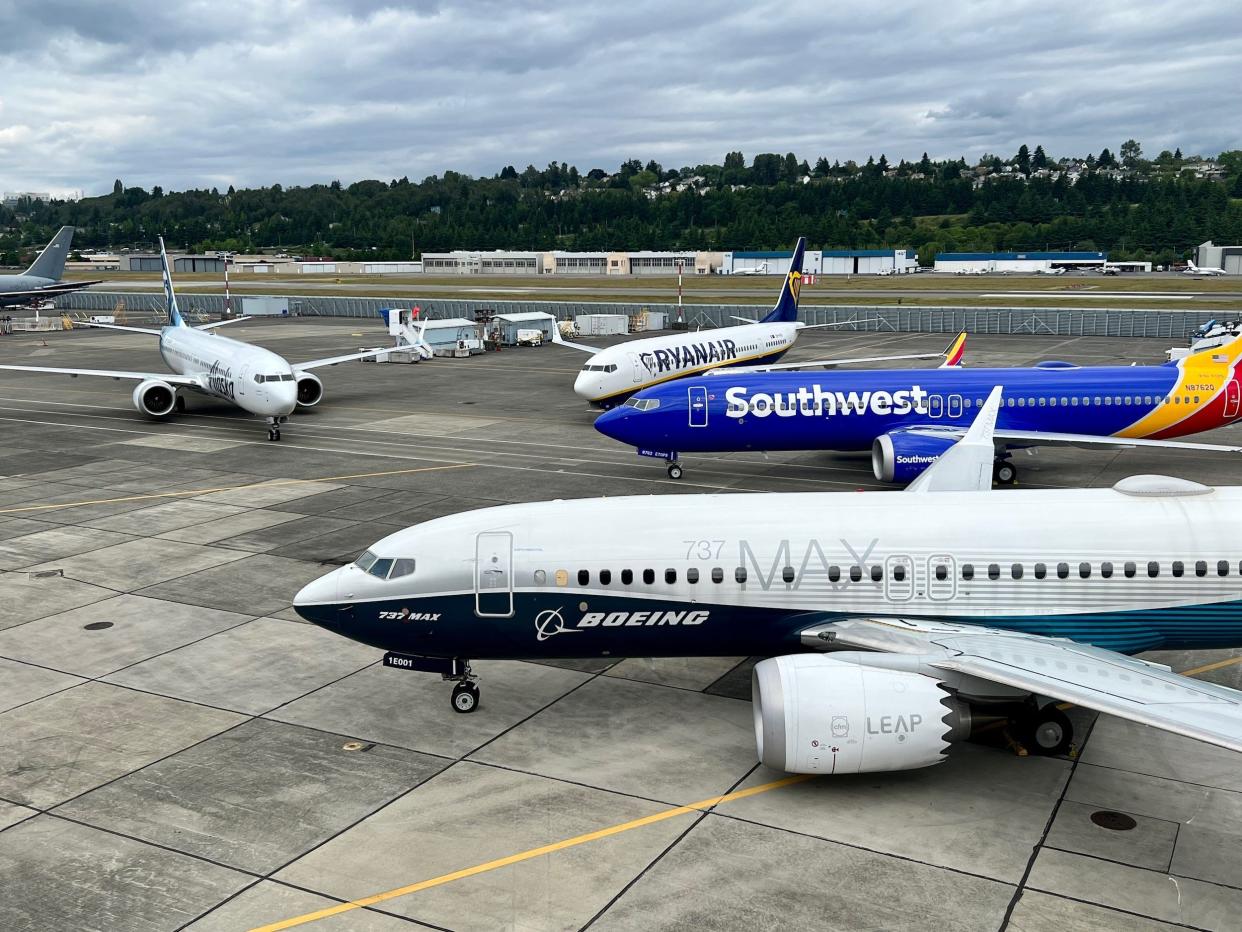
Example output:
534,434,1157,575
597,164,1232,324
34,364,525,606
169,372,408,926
472,676,755,804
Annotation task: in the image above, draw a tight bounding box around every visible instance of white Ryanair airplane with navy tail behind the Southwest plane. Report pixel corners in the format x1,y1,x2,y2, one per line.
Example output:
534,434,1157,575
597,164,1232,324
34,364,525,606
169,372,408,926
551,236,939,408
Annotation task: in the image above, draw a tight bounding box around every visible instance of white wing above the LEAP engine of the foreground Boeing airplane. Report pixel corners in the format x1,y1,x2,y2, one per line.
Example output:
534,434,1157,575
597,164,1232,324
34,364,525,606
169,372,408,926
802,619,1242,751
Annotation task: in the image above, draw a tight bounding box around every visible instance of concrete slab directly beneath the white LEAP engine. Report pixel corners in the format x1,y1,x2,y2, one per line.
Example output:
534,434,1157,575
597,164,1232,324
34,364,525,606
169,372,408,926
725,750,1069,884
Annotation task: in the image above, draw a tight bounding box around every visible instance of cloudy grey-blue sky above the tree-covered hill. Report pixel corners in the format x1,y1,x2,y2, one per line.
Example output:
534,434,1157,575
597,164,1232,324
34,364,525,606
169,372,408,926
0,0,1242,194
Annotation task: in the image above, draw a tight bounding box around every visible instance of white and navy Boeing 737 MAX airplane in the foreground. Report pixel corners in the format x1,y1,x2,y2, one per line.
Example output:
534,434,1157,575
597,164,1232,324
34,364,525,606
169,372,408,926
293,385,1242,773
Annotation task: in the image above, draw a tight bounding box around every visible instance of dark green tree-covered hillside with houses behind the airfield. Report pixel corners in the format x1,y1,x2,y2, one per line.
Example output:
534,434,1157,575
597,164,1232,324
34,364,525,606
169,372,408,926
0,140,1242,263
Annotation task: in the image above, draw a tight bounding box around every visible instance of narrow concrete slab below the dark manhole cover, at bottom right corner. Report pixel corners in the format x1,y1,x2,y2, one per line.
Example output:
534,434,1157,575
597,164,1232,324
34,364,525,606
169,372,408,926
1027,849,1242,930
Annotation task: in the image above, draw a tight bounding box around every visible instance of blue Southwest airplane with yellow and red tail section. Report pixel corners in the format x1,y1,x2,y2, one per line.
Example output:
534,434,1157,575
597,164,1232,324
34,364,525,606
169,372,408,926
595,337,1242,485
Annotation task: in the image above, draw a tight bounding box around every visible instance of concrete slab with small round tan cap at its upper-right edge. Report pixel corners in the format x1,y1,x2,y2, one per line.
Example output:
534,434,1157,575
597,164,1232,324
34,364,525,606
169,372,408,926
56,720,446,874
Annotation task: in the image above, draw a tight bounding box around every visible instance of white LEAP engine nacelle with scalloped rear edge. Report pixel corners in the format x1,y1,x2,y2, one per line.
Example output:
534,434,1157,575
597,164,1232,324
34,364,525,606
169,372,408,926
751,654,970,773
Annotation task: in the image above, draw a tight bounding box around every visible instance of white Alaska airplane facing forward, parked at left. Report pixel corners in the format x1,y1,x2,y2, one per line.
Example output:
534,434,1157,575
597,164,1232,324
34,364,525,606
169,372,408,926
0,237,388,440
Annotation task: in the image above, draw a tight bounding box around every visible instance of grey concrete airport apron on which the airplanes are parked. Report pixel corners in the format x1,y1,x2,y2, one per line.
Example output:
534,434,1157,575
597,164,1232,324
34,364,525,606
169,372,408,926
0,310,1242,932
